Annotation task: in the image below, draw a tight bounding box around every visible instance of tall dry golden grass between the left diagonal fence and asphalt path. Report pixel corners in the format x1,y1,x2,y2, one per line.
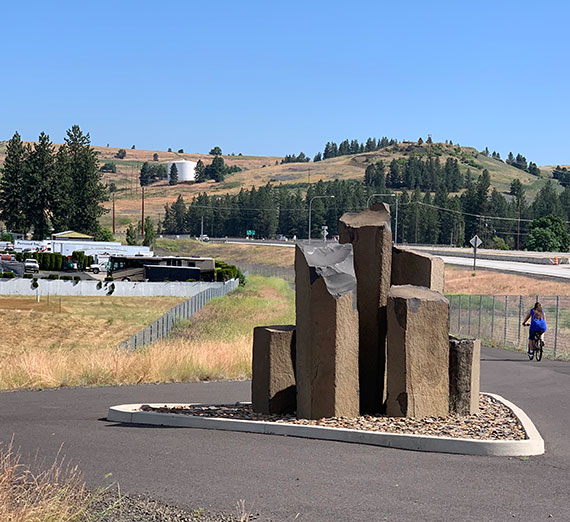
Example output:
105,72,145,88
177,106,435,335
0,277,294,389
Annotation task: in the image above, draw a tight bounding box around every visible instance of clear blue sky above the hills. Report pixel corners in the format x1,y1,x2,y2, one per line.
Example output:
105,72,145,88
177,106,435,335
0,0,570,165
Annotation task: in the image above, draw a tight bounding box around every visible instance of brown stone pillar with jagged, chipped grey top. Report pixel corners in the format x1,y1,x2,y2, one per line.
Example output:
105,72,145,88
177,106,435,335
295,241,359,419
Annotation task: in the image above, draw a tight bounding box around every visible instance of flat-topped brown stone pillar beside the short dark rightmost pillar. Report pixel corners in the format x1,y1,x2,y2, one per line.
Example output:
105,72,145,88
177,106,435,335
386,285,449,418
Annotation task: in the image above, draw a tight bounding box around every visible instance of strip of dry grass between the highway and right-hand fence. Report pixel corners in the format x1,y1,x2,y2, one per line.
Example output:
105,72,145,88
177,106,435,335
445,266,570,296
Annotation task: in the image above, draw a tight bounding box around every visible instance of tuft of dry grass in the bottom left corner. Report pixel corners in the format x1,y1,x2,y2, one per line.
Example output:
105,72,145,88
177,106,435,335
0,438,101,522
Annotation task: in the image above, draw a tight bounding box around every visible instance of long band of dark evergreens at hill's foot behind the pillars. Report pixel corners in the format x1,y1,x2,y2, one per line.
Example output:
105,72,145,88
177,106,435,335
161,170,570,251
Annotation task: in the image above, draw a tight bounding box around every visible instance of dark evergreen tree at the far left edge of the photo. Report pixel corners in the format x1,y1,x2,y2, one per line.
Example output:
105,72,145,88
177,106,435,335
0,132,28,233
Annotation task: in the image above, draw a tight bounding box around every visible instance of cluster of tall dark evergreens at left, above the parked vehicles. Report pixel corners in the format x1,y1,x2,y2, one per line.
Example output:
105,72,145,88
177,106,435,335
0,125,108,239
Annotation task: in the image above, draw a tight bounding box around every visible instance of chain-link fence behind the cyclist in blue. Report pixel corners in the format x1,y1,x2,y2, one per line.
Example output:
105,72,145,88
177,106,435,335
446,294,570,357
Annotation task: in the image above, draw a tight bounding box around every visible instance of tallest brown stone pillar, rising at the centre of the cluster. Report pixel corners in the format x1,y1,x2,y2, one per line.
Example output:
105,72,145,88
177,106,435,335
339,203,392,414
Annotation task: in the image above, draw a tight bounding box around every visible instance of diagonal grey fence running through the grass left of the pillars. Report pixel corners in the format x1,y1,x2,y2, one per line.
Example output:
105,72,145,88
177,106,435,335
119,279,239,350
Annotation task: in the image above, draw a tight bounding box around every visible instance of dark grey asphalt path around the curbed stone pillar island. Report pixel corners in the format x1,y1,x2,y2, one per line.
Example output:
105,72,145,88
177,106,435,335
0,348,570,522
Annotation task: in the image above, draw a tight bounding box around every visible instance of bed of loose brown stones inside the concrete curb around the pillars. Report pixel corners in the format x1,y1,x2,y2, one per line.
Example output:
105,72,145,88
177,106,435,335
141,395,527,440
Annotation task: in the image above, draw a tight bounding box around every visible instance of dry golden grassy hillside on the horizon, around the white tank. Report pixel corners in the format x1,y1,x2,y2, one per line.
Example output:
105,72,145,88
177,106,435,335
0,138,561,229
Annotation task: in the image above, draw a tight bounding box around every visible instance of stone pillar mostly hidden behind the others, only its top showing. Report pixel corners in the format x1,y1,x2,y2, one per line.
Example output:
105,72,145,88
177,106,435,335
392,245,445,292
